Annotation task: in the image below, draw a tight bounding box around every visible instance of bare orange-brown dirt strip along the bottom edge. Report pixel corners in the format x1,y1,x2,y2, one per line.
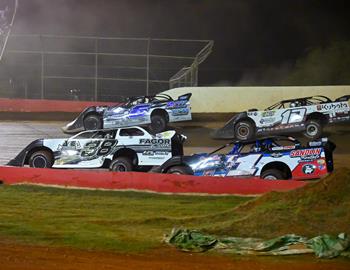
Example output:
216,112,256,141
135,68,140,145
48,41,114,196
0,242,350,270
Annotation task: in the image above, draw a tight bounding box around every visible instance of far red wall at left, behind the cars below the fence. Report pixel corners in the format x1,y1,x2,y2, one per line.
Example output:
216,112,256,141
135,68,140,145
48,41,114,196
0,98,118,113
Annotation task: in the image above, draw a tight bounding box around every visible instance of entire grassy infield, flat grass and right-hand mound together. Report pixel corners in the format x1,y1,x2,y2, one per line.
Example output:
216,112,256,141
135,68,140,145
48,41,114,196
0,169,350,252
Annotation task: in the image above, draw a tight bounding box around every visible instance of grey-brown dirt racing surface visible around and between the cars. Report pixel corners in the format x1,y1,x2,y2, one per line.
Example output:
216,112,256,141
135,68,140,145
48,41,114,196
0,121,350,165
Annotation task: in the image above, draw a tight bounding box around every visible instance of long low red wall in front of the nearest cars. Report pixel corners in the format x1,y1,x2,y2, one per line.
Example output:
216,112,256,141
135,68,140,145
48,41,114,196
0,166,306,195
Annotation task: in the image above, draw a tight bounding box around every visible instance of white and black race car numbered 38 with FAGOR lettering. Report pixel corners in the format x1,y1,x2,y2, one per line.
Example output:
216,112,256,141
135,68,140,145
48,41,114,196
8,126,186,171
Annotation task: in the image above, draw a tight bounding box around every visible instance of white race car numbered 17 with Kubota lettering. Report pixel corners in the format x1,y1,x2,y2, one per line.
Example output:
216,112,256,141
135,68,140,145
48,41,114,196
211,95,350,140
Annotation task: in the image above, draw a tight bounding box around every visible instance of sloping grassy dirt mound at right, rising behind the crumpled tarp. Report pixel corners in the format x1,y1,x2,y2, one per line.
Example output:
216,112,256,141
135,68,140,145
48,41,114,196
210,168,350,238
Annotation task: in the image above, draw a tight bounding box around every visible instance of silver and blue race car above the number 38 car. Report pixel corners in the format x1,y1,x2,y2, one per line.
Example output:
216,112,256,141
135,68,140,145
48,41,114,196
62,93,192,134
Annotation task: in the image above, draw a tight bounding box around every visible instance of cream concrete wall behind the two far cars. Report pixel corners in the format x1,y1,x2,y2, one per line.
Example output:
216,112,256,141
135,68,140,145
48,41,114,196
164,85,350,113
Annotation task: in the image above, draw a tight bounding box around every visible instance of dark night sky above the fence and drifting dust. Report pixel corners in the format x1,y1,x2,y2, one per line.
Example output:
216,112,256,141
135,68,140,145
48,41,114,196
10,0,350,84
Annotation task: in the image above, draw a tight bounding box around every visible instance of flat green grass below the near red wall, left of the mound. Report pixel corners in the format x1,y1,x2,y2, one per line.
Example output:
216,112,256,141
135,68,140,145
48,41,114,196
0,186,249,252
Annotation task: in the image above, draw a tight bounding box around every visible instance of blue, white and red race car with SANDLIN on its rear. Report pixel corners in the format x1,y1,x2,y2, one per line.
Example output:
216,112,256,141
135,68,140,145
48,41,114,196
154,136,335,180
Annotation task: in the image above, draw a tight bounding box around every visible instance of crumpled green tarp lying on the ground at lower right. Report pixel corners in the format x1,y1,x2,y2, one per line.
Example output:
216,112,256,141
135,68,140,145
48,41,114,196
165,228,350,258
